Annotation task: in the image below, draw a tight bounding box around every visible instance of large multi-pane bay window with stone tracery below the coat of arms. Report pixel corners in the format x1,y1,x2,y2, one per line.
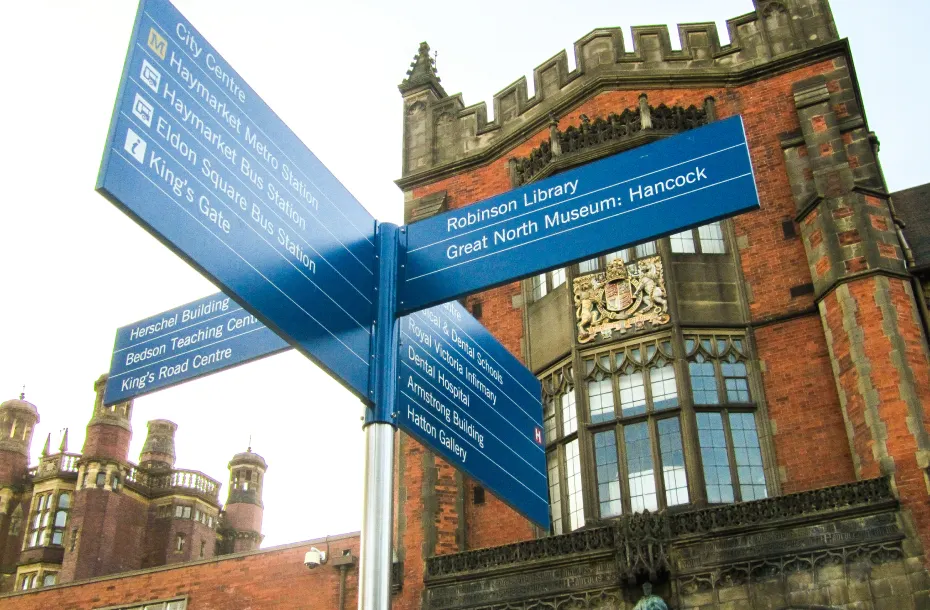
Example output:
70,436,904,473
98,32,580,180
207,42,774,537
542,331,768,533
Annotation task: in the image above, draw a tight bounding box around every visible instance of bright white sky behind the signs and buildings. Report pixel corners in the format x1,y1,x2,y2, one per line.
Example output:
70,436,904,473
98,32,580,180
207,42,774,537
0,0,930,547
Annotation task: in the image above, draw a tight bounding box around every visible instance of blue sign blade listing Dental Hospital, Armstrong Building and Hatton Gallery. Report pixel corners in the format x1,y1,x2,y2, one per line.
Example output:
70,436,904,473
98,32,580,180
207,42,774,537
397,301,549,530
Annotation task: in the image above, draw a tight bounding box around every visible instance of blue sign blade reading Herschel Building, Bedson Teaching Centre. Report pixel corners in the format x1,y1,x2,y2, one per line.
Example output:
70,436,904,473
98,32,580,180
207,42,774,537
103,292,290,405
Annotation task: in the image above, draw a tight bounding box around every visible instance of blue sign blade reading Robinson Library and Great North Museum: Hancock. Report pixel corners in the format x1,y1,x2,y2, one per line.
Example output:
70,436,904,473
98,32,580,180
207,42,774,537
398,116,759,313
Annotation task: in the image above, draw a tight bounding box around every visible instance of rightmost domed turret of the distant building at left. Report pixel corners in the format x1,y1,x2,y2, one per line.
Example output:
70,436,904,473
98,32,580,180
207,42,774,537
223,447,268,553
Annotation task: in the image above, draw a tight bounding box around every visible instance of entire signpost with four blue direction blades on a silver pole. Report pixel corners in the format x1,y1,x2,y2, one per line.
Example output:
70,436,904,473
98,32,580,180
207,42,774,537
97,0,759,610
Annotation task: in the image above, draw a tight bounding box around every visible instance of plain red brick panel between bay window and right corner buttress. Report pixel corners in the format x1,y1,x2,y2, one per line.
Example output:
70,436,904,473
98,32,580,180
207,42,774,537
755,314,856,493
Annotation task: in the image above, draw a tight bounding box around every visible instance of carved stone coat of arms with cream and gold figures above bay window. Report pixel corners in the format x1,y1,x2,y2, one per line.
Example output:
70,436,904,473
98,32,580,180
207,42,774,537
572,256,670,343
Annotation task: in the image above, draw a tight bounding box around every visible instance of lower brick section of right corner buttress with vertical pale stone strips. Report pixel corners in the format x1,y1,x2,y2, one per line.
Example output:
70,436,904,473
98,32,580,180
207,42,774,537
820,276,930,548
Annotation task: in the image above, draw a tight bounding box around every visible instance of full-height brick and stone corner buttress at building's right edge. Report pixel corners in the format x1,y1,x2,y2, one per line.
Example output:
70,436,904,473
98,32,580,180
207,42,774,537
785,73,930,546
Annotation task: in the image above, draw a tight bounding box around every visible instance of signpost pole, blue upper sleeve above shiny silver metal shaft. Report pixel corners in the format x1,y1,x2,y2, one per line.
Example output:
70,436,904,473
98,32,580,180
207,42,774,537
358,223,398,610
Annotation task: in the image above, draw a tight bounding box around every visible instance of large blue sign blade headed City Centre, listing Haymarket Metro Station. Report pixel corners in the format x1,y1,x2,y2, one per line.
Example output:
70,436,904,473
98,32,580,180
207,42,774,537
97,0,375,398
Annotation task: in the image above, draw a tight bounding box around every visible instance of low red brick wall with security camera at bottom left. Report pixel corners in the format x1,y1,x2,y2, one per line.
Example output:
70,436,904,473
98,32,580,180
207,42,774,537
0,536,359,610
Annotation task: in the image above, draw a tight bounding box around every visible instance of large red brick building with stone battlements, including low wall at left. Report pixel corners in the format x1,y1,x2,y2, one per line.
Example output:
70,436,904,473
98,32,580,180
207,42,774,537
0,0,930,610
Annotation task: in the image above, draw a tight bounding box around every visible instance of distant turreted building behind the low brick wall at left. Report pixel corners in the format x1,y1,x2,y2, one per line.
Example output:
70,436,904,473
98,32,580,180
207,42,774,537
0,376,267,591
